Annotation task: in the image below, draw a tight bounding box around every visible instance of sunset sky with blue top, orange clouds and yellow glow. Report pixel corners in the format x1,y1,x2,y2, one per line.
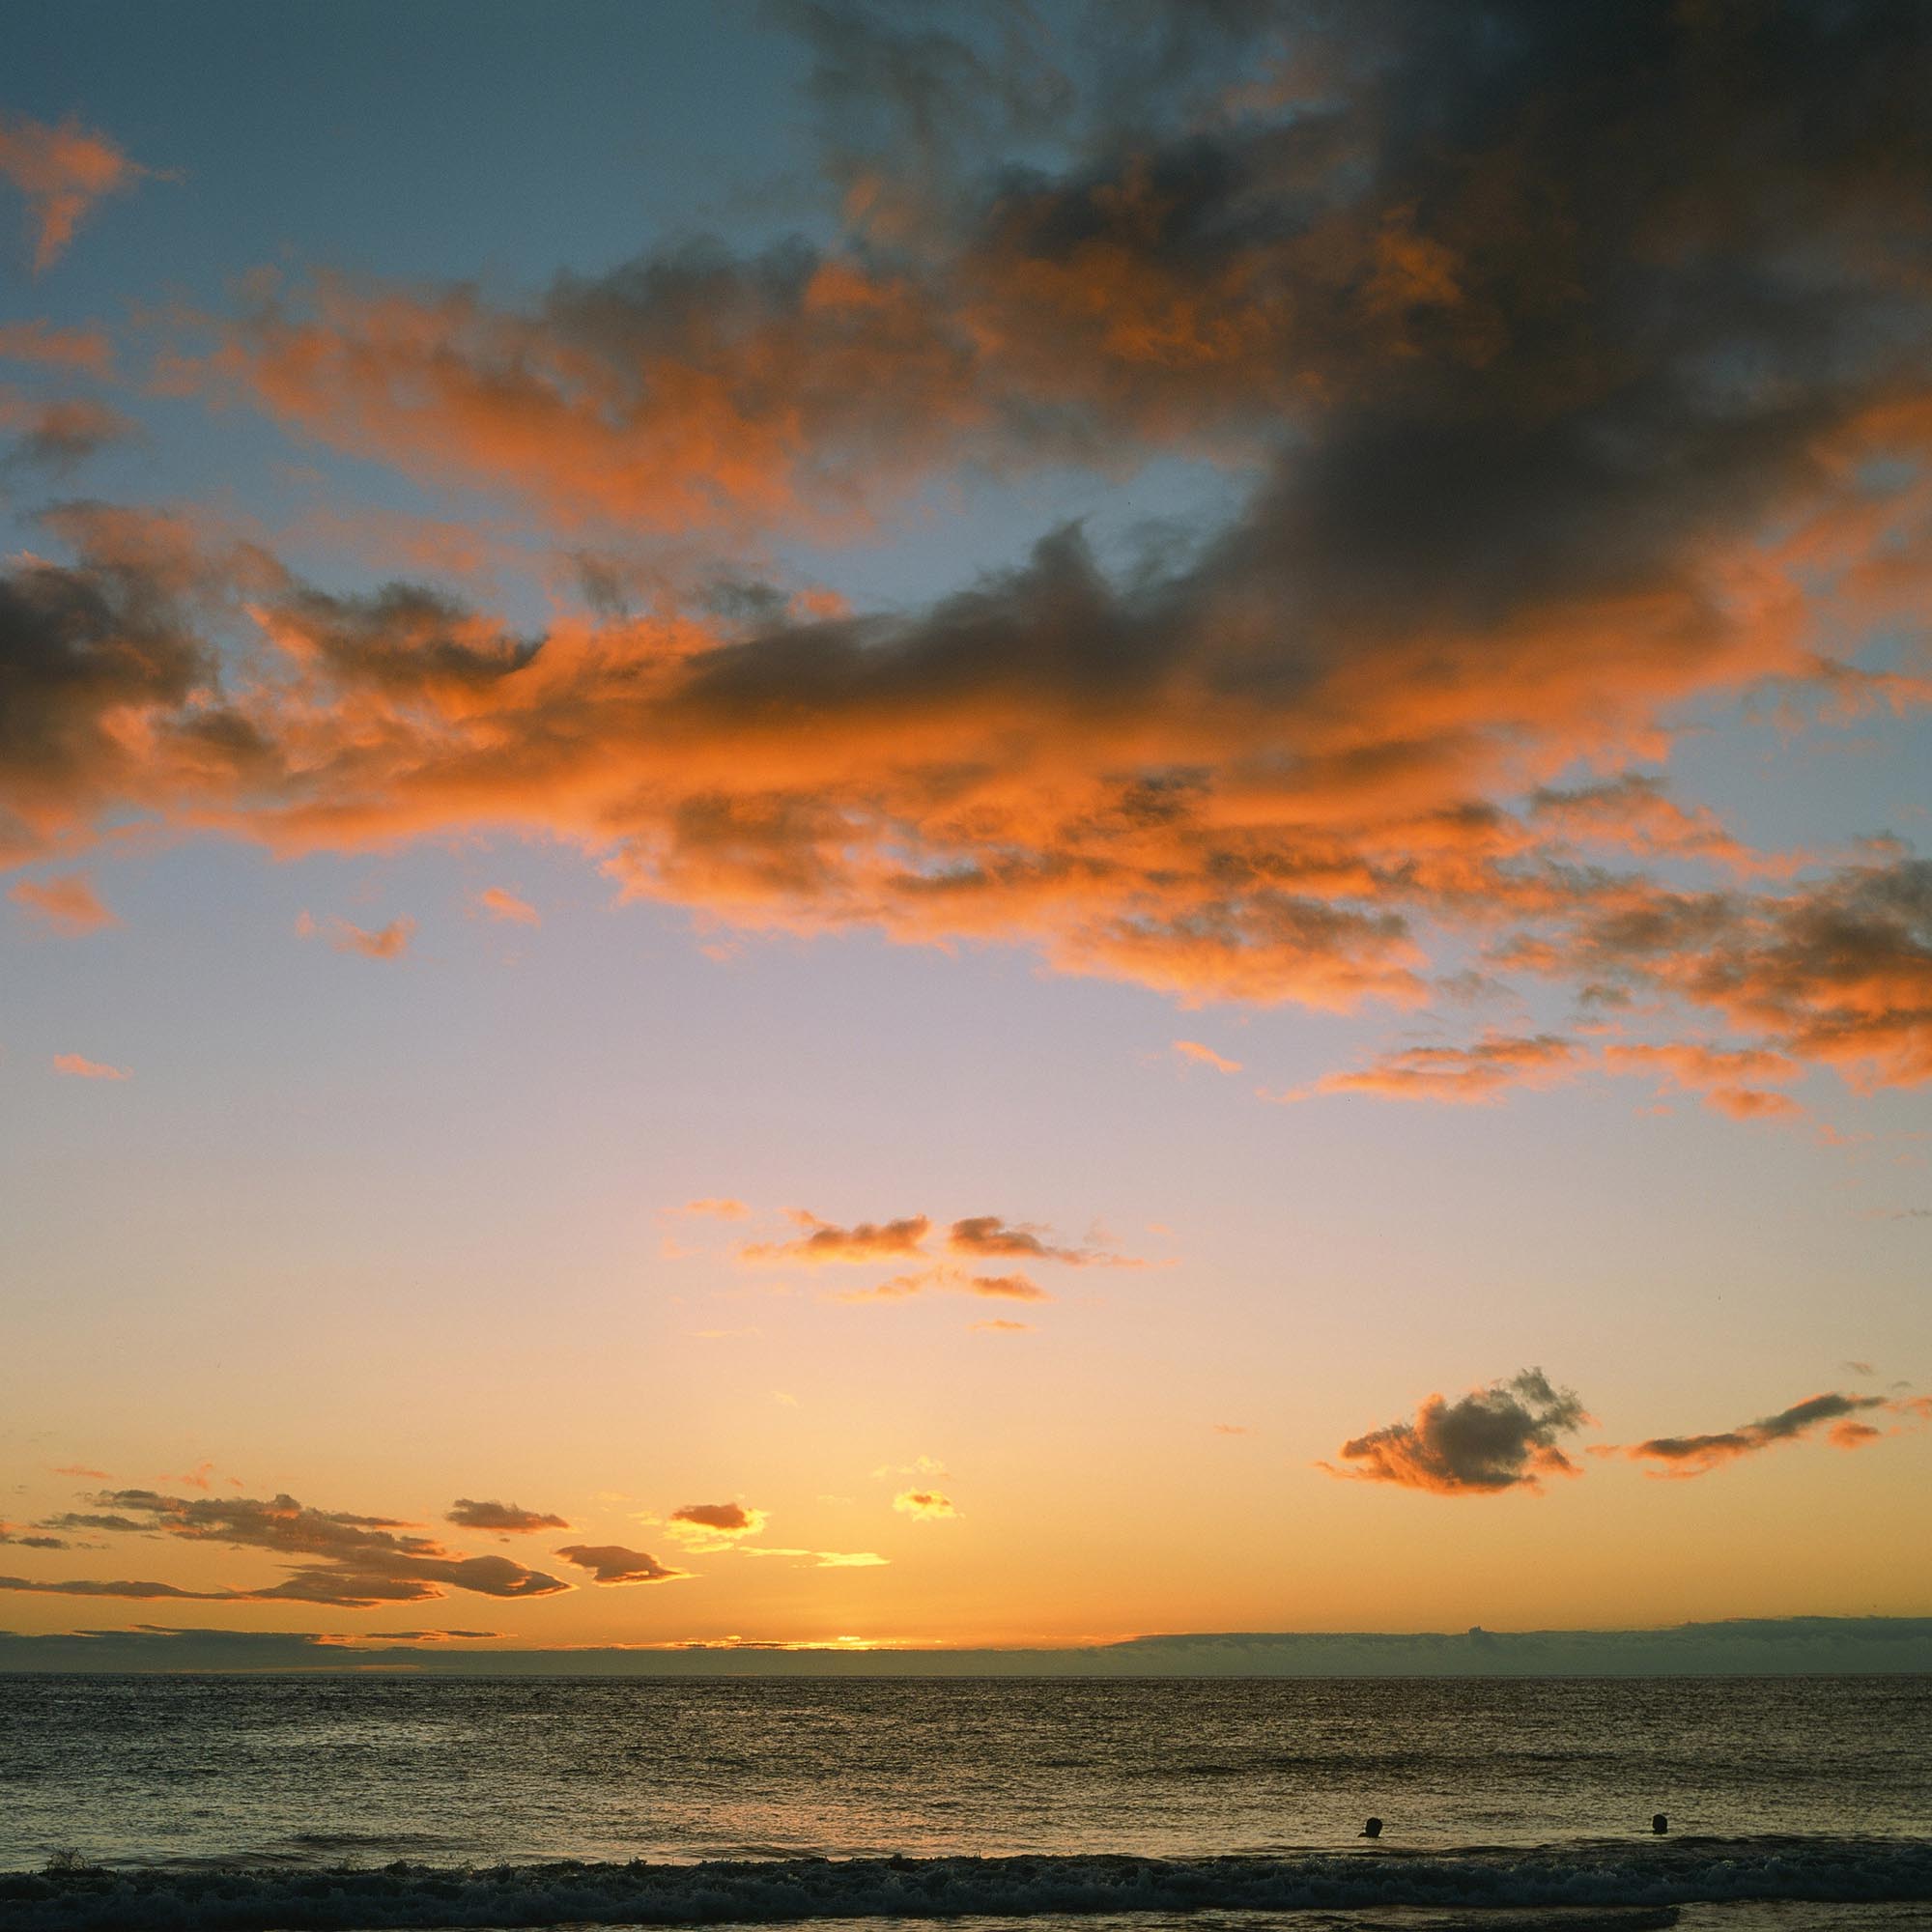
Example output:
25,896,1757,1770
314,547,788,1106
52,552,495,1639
0,0,1932,1648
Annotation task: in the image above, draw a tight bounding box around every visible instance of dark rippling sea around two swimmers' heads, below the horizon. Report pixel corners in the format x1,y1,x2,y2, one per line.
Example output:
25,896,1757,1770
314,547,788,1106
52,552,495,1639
0,1673,1932,1932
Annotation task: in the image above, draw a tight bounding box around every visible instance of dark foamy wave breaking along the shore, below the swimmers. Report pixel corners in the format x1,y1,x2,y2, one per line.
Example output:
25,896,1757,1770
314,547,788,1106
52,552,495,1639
0,1837,1932,1932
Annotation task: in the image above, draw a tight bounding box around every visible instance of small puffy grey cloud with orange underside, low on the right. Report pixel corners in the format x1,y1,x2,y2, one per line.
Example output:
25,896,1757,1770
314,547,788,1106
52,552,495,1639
1318,1368,1590,1495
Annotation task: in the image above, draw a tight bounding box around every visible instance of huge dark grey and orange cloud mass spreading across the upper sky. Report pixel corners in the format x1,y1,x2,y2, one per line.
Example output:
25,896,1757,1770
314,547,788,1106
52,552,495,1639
0,8,1932,1113
